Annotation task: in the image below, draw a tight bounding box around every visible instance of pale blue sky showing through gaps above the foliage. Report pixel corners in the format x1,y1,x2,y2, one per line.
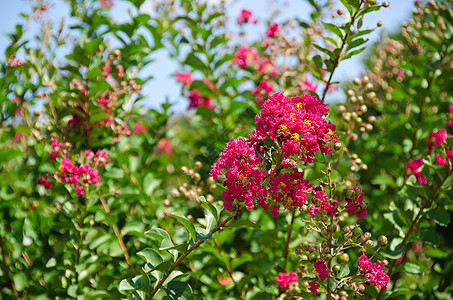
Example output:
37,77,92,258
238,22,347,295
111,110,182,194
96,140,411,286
0,0,413,110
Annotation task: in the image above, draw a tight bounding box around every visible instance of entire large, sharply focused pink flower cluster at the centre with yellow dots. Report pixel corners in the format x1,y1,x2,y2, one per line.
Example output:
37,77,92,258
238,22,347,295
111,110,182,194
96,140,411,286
211,93,340,216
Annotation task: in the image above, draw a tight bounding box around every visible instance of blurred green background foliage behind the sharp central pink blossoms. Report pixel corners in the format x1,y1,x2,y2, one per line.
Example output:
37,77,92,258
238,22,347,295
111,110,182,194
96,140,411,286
0,0,453,299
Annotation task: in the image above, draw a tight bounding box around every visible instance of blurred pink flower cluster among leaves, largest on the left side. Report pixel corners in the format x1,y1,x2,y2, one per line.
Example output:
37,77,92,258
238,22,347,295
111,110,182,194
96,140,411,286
38,137,110,196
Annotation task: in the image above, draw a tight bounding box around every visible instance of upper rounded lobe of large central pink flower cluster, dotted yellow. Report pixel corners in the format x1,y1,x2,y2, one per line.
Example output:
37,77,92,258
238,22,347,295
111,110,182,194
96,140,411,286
250,93,338,163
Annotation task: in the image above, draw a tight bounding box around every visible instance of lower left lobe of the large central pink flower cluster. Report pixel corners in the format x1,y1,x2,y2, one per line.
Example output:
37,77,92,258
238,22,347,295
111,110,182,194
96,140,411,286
210,137,269,211
